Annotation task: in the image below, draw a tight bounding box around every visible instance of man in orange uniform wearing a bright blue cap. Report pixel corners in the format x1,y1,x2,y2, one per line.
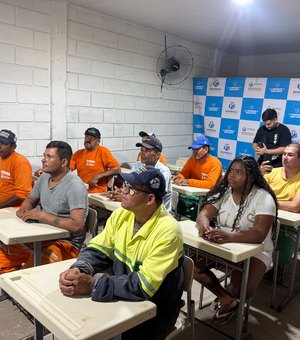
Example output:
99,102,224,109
173,136,222,189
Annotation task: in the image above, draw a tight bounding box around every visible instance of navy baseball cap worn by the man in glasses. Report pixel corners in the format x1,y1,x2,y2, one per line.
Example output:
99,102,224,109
118,166,166,199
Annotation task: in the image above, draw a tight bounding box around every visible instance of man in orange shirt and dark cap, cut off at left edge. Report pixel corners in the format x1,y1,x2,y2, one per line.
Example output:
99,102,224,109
0,130,32,209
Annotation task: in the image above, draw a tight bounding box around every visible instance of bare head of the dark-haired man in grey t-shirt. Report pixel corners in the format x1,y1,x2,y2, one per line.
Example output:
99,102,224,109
42,141,72,175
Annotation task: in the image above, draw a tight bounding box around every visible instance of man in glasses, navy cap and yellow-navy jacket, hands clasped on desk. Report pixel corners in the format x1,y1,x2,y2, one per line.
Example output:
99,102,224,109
59,167,183,340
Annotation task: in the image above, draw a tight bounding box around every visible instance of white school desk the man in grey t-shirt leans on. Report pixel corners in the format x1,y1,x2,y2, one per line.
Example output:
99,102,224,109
0,208,70,266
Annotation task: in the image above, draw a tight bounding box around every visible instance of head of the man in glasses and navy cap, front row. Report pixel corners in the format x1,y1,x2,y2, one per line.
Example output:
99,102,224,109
118,166,166,212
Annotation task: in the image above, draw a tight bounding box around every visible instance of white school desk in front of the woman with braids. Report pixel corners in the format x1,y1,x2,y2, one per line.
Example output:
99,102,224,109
179,220,263,340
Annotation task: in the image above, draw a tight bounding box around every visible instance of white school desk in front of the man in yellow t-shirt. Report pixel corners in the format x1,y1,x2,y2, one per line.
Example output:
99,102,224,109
277,210,300,312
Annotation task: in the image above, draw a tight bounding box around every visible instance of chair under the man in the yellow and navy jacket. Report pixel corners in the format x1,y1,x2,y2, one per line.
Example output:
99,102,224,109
165,256,195,340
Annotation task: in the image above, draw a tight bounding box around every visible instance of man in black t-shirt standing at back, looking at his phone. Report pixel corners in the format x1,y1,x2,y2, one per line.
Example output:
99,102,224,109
252,109,292,168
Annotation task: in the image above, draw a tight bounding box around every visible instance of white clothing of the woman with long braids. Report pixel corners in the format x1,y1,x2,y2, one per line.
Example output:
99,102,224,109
213,186,276,269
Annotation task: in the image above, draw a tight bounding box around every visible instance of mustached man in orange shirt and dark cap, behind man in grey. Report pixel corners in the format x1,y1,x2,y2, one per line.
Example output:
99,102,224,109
71,127,120,193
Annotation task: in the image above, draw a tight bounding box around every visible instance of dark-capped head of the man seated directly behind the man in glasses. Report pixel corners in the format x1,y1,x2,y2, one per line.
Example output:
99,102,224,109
135,136,162,166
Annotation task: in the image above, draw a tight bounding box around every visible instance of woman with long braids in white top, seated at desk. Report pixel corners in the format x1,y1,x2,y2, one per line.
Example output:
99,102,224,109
194,155,277,325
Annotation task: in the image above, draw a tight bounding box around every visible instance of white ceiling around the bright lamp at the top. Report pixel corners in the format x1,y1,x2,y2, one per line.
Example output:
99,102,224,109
67,0,300,55
